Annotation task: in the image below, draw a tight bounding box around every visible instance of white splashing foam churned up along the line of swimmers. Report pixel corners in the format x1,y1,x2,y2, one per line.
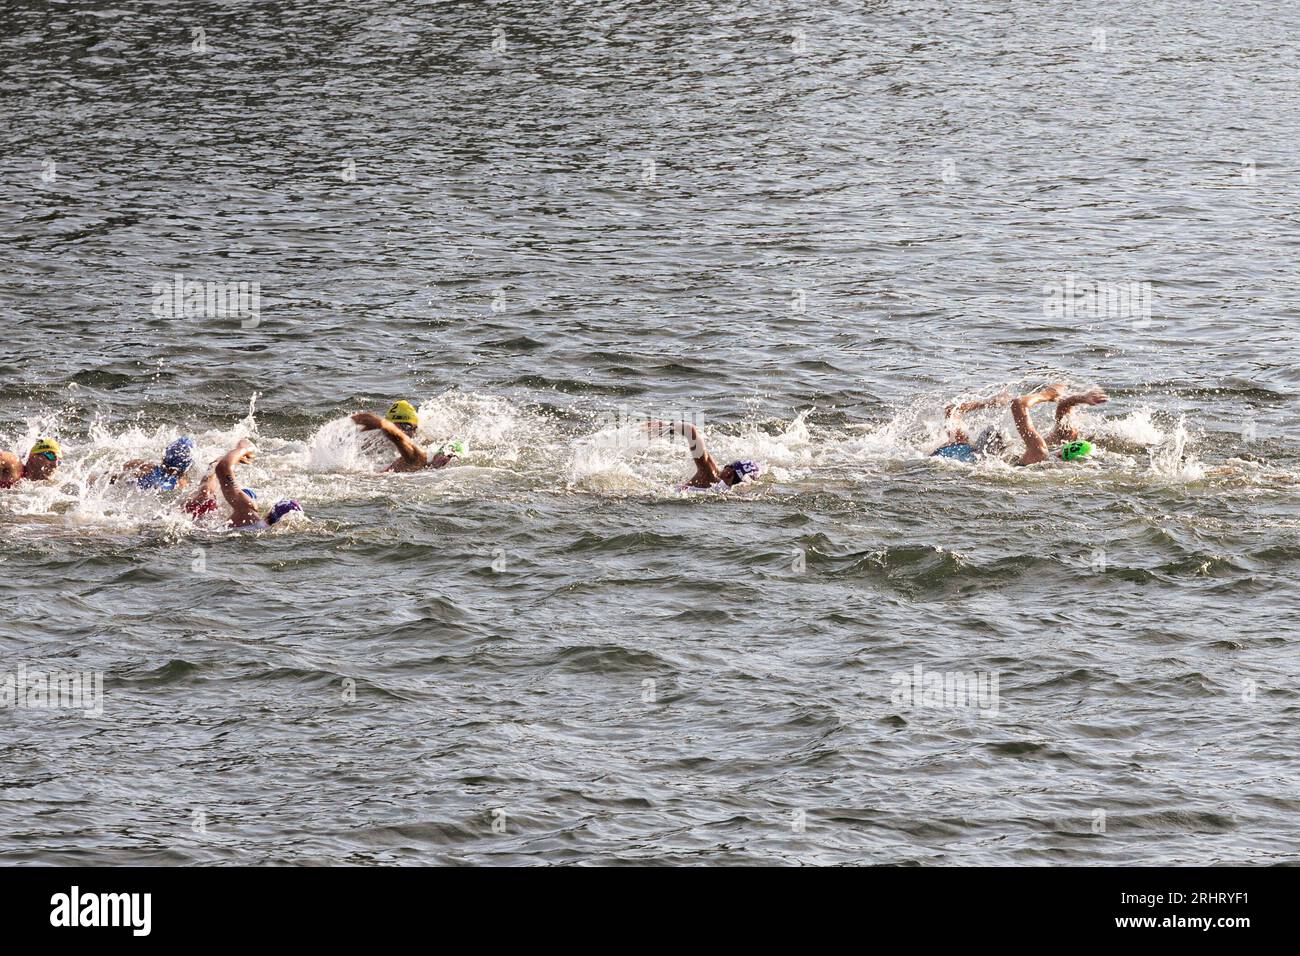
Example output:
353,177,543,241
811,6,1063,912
0,384,1284,533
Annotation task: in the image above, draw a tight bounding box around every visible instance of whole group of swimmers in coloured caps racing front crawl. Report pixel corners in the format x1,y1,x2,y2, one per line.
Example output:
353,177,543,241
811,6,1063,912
0,385,1110,531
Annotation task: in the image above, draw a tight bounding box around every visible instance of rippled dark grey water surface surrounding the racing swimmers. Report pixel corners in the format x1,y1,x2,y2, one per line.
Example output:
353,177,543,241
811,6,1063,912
0,0,1300,865
